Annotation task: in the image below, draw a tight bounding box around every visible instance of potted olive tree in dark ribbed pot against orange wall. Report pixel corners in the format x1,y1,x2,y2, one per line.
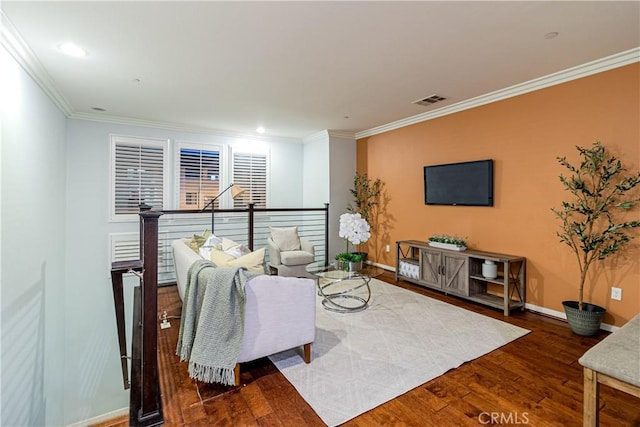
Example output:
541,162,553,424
552,141,640,336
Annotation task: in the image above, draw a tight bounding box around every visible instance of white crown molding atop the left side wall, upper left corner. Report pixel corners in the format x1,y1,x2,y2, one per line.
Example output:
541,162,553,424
0,10,73,117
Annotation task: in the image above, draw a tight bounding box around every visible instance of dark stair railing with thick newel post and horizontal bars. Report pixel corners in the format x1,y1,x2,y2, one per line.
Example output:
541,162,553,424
111,204,329,427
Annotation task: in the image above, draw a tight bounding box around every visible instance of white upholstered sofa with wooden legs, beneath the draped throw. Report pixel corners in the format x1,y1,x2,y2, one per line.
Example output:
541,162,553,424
171,239,316,385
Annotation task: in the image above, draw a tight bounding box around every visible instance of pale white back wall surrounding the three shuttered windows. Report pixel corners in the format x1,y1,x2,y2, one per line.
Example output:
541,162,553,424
65,120,303,423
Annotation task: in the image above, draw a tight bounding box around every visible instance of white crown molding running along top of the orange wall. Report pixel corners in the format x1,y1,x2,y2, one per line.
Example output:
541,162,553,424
355,47,640,139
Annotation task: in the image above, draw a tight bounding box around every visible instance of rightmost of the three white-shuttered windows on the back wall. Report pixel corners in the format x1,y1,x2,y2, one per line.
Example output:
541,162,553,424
233,152,268,209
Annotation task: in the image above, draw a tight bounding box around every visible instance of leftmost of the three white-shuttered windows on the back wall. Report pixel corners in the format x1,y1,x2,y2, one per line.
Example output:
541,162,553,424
111,135,168,219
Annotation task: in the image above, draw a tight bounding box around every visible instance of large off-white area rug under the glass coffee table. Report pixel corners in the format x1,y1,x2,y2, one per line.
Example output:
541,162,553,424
270,279,530,426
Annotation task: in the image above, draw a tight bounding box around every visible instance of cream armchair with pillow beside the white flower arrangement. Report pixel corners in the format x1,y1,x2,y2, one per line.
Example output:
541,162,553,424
267,227,316,278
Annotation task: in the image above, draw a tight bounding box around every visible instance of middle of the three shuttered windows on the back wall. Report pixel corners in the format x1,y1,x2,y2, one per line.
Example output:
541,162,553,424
178,143,221,209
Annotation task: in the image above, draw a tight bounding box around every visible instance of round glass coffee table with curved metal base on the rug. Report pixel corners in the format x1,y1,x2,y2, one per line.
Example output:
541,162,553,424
306,261,383,313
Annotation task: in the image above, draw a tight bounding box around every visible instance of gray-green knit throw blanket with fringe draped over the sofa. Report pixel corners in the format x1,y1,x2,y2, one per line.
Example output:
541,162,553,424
176,260,256,385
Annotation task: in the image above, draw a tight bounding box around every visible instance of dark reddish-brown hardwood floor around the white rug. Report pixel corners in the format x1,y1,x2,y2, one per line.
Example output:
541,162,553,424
100,272,640,427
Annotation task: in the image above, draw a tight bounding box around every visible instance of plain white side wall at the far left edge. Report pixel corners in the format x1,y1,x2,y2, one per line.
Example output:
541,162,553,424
0,47,67,426
